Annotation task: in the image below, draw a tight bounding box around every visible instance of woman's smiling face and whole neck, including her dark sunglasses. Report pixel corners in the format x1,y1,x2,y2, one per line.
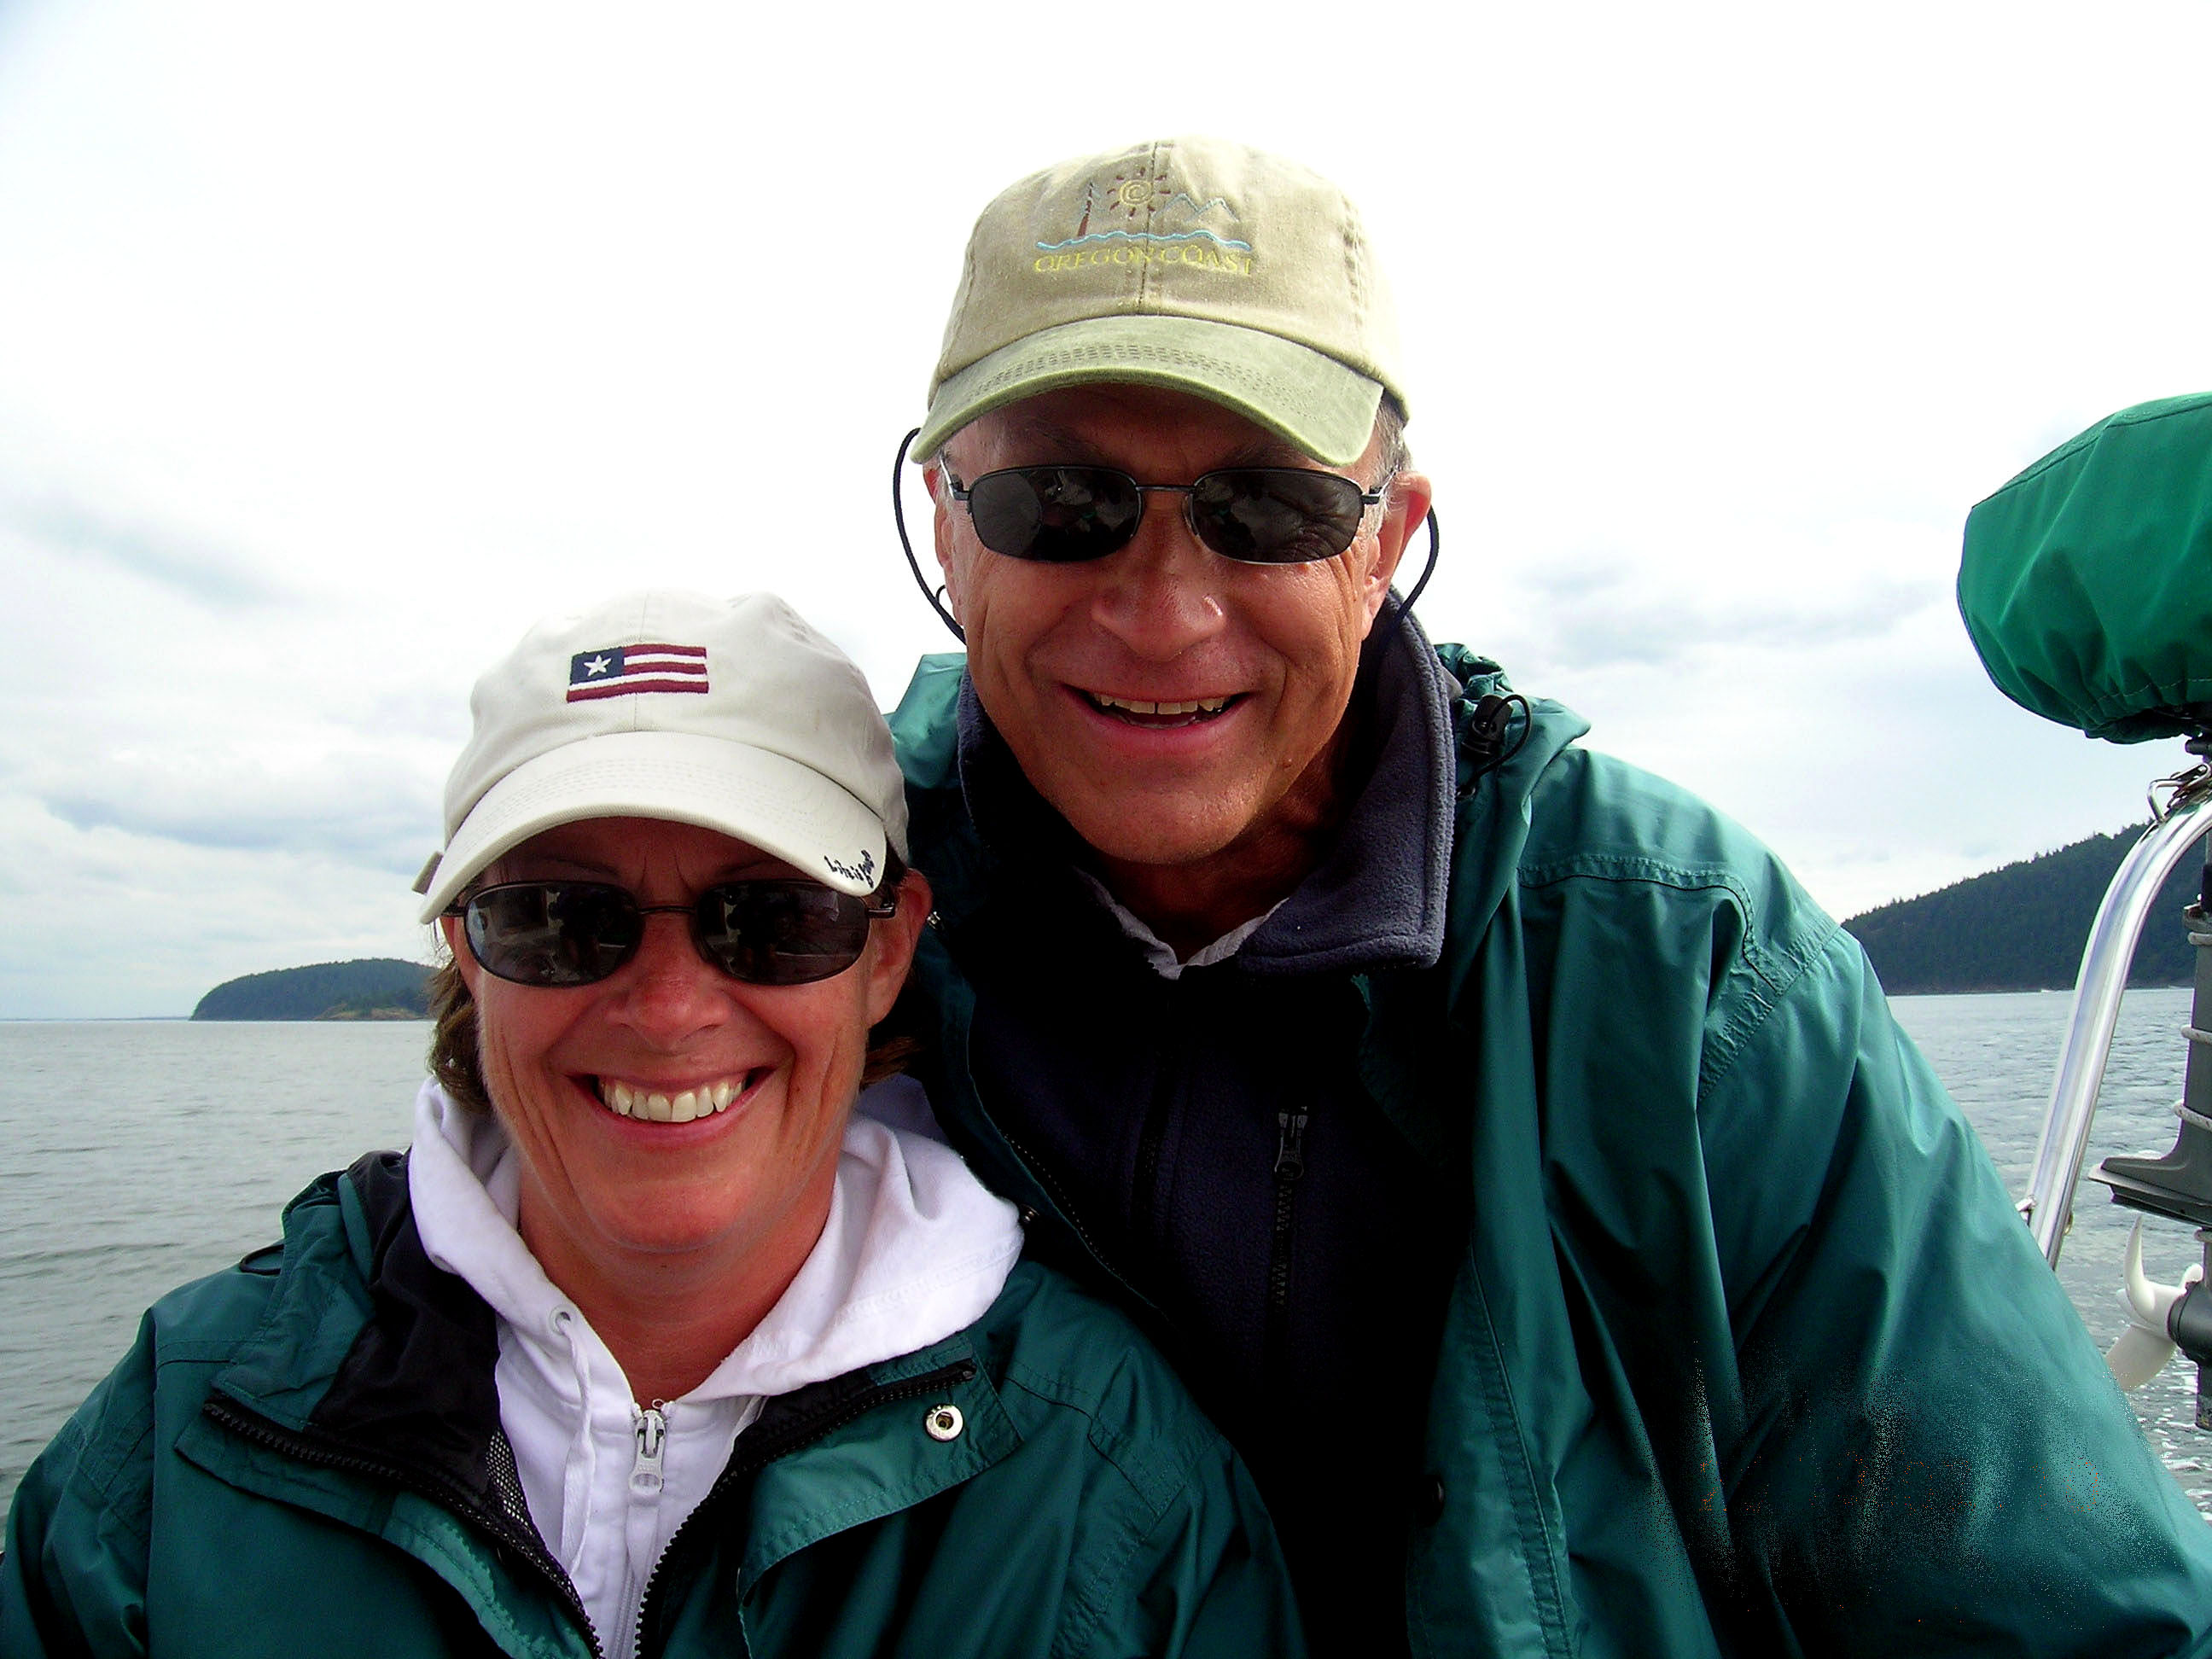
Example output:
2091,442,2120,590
442,818,916,1400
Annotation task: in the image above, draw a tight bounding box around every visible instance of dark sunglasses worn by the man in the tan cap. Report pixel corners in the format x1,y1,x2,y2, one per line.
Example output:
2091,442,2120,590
945,467,1389,564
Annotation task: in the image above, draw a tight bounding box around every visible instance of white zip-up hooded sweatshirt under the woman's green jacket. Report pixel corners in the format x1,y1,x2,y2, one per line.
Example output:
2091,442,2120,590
407,1077,1022,1659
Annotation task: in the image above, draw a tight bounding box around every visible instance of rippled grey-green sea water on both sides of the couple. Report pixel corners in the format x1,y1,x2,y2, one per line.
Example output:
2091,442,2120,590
0,991,2212,1513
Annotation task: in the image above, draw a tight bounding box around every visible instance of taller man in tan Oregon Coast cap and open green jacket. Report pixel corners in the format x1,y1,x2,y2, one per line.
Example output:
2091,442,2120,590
894,139,2212,1655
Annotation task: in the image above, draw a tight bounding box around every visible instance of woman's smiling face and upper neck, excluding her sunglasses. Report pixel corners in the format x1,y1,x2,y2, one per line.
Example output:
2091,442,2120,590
445,818,929,1294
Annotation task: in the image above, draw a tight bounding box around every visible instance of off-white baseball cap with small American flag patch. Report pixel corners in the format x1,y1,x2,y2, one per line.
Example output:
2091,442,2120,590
416,591,907,923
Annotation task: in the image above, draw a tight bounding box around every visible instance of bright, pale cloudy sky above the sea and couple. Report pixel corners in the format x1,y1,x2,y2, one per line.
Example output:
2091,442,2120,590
0,0,2212,1020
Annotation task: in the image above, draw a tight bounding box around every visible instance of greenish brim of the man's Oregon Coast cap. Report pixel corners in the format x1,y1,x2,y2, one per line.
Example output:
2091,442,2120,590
913,317,1382,467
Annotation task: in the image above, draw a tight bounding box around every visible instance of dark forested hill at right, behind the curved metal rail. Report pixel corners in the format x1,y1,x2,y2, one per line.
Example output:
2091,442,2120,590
1845,823,2203,995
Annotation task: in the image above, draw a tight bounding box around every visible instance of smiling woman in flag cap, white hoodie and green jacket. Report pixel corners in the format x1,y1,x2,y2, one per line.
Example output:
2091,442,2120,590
0,593,1296,1659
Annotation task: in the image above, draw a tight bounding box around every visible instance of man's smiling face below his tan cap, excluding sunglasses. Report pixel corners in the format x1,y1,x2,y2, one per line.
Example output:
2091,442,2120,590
931,385,1427,884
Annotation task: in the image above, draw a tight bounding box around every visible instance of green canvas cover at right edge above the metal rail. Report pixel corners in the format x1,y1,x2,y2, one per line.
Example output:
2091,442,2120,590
1958,392,2212,743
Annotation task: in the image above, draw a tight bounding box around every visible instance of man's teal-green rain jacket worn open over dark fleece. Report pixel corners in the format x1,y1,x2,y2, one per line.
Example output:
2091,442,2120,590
892,646,2212,1656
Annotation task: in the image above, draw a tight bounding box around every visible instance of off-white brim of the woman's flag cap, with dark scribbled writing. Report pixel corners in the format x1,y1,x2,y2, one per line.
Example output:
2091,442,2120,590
422,732,885,923
